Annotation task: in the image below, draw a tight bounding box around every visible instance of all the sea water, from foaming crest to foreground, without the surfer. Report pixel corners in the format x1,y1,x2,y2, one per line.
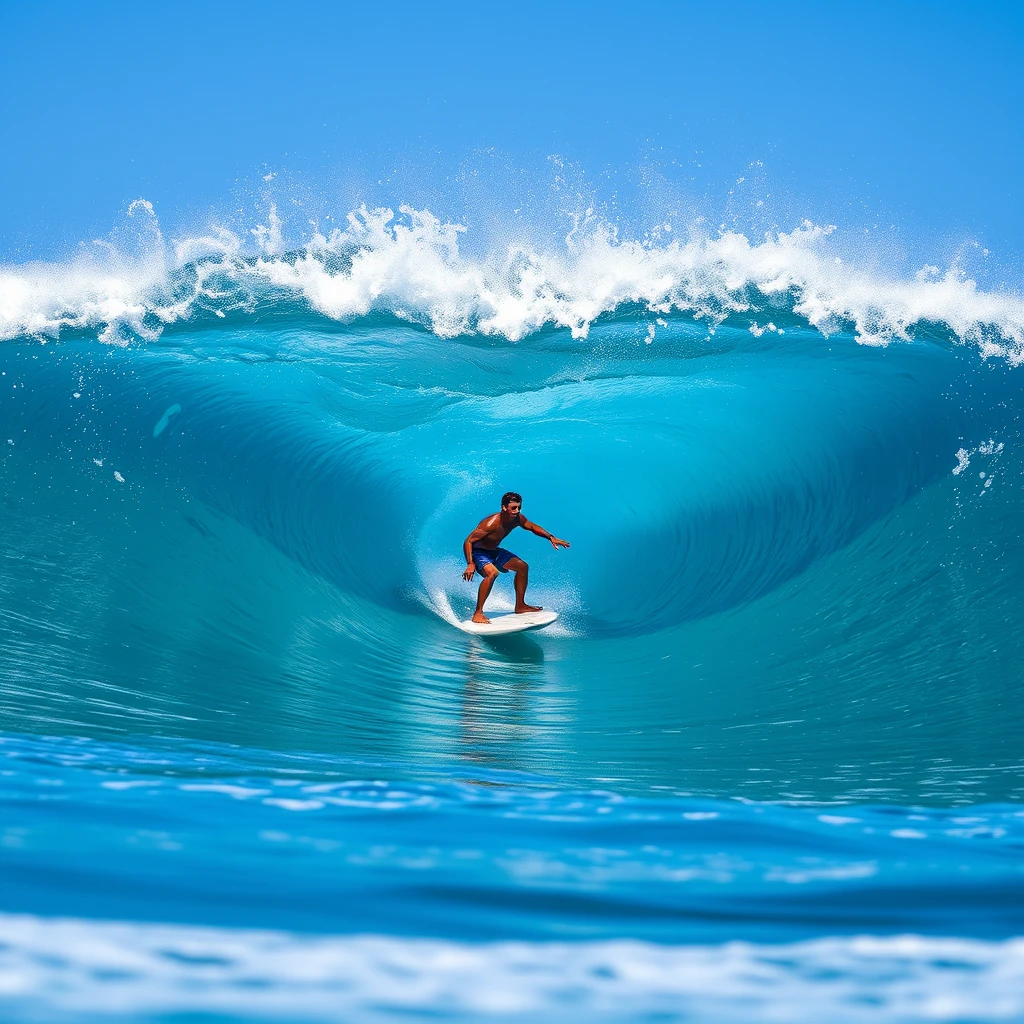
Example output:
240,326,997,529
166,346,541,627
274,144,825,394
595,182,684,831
0,203,1024,1024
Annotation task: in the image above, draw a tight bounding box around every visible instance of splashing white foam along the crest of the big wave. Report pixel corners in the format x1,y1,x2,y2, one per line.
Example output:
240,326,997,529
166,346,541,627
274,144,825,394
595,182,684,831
0,201,1024,362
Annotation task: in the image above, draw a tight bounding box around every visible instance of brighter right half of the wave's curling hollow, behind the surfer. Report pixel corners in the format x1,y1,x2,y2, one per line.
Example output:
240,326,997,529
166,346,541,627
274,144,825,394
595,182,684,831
410,344,984,637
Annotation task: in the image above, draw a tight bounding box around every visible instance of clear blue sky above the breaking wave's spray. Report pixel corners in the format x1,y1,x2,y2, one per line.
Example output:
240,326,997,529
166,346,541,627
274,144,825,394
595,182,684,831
0,0,1024,267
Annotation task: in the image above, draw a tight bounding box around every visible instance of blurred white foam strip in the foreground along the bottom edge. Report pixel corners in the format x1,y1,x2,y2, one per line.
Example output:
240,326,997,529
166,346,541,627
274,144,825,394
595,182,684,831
0,914,1024,1024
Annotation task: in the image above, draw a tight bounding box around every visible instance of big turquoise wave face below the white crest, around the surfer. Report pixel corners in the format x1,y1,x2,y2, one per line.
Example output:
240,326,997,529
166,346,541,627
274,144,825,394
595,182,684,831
0,232,1024,803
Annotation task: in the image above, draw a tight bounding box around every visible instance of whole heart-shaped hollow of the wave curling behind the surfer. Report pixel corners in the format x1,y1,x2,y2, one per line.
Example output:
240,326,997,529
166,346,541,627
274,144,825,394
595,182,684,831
3,323,997,637
